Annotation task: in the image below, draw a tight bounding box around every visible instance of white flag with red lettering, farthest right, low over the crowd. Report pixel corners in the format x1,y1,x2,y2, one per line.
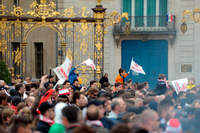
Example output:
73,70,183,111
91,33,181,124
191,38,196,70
171,78,188,94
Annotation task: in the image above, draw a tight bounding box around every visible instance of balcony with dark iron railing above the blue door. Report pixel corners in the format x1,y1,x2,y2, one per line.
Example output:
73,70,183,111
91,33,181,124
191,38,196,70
113,16,176,36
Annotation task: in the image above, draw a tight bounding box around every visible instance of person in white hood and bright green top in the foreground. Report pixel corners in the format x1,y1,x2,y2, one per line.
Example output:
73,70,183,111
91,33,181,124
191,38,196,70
48,103,67,133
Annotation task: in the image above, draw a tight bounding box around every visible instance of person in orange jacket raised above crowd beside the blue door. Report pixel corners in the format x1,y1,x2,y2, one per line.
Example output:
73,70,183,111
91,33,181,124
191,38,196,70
115,68,129,85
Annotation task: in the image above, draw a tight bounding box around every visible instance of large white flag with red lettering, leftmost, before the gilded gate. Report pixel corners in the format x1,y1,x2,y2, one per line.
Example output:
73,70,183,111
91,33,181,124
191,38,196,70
53,57,72,81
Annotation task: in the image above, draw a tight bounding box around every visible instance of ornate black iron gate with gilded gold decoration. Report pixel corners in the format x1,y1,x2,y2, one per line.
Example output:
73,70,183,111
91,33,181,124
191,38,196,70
0,0,128,83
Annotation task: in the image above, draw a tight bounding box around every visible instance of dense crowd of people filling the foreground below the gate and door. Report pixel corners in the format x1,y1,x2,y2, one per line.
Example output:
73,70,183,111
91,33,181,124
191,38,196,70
0,68,200,133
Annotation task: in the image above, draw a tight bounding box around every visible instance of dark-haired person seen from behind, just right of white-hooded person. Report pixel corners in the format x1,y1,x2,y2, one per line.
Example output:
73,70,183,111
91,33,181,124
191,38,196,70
62,104,82,133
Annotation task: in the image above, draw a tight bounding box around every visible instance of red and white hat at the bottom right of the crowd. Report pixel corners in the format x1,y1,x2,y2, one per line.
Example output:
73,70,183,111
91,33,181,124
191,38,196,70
166,119,182,133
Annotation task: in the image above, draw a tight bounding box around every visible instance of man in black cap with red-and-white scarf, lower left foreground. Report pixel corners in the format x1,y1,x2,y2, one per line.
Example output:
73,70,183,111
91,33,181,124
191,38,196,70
36,102,54,133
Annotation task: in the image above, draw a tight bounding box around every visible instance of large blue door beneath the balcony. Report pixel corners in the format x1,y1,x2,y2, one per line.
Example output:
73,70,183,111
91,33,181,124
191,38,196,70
121,40,168,89
